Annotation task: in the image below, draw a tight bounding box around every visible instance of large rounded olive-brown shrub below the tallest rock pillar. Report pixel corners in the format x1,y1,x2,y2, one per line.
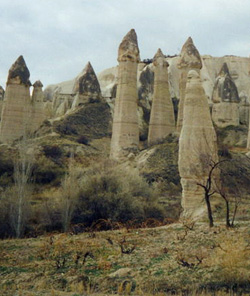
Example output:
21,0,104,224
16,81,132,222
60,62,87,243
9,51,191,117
73,161,164,225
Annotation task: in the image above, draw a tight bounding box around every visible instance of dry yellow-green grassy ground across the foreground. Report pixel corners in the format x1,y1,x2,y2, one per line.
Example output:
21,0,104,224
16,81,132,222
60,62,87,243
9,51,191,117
0,224,250,296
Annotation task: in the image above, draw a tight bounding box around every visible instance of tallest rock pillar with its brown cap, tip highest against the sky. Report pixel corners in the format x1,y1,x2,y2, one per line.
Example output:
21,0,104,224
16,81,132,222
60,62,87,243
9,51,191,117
110,29,140,160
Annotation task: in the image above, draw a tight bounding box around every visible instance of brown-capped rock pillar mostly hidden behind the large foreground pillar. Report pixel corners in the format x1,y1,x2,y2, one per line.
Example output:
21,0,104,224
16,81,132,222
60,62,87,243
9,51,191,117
176,37,202,133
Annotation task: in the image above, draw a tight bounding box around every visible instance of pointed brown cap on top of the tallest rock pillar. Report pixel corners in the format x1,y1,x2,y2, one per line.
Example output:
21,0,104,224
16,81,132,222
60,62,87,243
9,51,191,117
118,29,140,62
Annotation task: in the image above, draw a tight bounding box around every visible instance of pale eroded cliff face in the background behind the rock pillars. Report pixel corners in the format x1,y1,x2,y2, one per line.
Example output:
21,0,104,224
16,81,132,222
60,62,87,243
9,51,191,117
45,48,250,146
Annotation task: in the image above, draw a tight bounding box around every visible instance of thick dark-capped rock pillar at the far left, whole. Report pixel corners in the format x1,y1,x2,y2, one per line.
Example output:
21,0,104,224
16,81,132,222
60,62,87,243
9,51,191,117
0,56,31,143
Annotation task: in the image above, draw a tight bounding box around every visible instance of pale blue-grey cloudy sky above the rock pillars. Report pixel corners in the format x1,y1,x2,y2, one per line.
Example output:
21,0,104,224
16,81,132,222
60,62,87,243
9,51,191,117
0,0,250,88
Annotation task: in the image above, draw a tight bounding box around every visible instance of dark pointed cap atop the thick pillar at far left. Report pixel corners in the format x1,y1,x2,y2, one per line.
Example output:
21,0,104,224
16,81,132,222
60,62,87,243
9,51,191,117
7,56,31,86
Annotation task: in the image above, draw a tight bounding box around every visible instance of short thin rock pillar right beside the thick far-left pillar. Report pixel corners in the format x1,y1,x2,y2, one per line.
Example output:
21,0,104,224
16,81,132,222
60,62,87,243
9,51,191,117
31,80,46,131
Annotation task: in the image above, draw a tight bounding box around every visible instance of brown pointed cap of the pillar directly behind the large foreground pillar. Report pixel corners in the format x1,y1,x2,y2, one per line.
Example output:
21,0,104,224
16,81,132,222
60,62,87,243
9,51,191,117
178,37,202,69
